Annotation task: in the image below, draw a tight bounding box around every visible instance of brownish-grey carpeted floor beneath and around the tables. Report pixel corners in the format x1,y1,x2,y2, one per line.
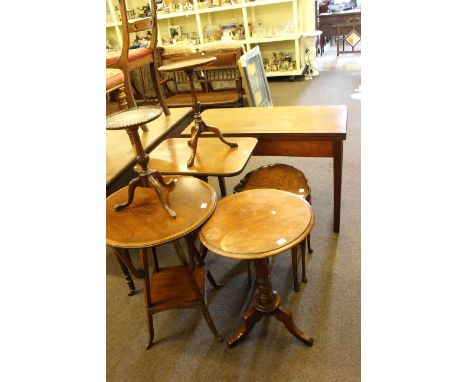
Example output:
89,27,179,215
107,49,361,382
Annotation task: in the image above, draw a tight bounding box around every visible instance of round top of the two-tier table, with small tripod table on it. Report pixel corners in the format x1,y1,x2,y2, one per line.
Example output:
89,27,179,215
106,177,216,248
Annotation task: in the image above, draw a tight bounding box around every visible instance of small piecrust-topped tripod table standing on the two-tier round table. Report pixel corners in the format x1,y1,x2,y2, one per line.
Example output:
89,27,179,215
106,106,176,219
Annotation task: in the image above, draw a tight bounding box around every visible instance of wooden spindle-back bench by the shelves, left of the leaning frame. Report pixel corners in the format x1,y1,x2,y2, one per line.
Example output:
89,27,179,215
162,48,243,109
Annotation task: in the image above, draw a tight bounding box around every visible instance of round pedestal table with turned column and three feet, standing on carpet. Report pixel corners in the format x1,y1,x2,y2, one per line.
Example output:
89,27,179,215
199,189,314,347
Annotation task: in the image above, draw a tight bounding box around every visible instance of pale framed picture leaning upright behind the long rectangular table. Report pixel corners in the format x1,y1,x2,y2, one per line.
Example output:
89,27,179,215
238,46,273,107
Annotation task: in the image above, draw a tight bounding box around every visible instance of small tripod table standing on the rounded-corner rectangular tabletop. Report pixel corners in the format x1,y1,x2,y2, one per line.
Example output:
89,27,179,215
159,57,238,167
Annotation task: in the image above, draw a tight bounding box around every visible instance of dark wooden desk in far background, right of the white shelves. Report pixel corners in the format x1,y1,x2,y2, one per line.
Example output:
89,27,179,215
316,9,361,54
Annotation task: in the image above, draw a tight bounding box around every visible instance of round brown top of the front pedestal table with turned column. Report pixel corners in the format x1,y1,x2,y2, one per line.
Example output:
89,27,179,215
199,189,314,260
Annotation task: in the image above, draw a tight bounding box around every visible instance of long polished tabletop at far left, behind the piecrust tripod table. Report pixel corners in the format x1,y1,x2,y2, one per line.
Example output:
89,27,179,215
106,107,192,189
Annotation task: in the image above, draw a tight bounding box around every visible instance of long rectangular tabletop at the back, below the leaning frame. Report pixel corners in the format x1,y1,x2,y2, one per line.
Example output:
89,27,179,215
182,105,347,139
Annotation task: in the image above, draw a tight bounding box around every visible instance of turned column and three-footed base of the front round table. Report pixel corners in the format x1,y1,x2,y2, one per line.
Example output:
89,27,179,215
227,259,314,347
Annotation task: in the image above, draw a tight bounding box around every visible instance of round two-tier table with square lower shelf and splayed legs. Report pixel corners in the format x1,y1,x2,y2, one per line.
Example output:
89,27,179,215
106,177,221,349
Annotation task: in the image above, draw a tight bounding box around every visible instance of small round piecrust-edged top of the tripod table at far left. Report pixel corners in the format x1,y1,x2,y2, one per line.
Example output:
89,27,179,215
106,106,162,130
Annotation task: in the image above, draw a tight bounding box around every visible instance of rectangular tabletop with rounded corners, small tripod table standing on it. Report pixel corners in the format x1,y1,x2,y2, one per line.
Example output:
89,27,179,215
148,137,257,176
